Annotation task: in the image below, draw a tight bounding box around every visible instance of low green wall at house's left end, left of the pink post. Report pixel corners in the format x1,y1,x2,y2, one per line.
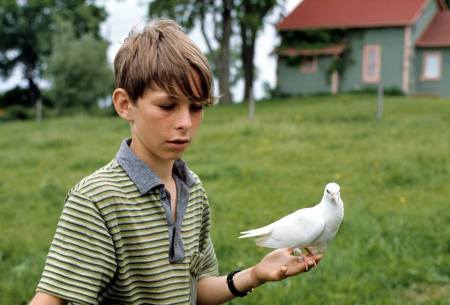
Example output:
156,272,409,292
277,56,332,95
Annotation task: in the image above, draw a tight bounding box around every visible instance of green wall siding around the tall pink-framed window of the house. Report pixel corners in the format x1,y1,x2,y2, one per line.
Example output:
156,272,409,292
340,28,404,91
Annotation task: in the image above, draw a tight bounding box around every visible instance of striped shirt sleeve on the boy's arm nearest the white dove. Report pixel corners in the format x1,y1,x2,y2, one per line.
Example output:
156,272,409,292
199,193,219,279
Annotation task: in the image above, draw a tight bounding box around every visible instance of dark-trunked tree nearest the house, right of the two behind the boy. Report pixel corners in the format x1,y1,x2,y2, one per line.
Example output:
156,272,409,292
236,0,278,101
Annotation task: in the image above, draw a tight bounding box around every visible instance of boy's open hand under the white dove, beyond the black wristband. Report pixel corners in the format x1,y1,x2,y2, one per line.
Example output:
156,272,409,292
252,248,322,285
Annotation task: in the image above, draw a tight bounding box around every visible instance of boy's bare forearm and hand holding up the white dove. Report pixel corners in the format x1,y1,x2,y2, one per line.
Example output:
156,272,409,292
197,248,321,305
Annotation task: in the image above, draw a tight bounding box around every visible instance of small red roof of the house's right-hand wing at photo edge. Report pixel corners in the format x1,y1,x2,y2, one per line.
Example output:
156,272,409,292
416,11,450,47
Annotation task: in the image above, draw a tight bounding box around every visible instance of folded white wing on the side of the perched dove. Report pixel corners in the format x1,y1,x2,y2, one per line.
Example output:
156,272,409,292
256,208,325,248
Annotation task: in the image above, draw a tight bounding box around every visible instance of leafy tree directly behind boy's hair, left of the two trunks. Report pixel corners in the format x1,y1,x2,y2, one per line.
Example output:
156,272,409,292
148,0,234,103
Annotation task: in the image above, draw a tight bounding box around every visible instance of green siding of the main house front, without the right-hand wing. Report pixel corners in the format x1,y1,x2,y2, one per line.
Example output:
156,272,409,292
277,28,404,94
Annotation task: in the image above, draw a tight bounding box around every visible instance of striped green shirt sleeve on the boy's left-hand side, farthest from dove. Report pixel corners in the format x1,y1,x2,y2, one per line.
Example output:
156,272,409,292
36,192,117,304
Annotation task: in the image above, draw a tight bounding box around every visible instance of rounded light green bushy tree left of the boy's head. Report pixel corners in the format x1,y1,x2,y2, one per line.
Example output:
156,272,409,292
45,21,113,113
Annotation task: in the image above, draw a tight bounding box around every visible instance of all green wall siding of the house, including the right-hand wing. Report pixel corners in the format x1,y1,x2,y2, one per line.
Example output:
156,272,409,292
277,0,450,96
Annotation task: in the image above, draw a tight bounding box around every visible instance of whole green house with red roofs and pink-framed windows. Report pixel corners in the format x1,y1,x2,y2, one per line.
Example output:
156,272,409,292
276,0,450,96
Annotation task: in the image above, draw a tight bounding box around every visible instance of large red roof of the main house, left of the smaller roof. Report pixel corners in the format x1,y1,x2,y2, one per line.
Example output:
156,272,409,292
277,0,445,31
